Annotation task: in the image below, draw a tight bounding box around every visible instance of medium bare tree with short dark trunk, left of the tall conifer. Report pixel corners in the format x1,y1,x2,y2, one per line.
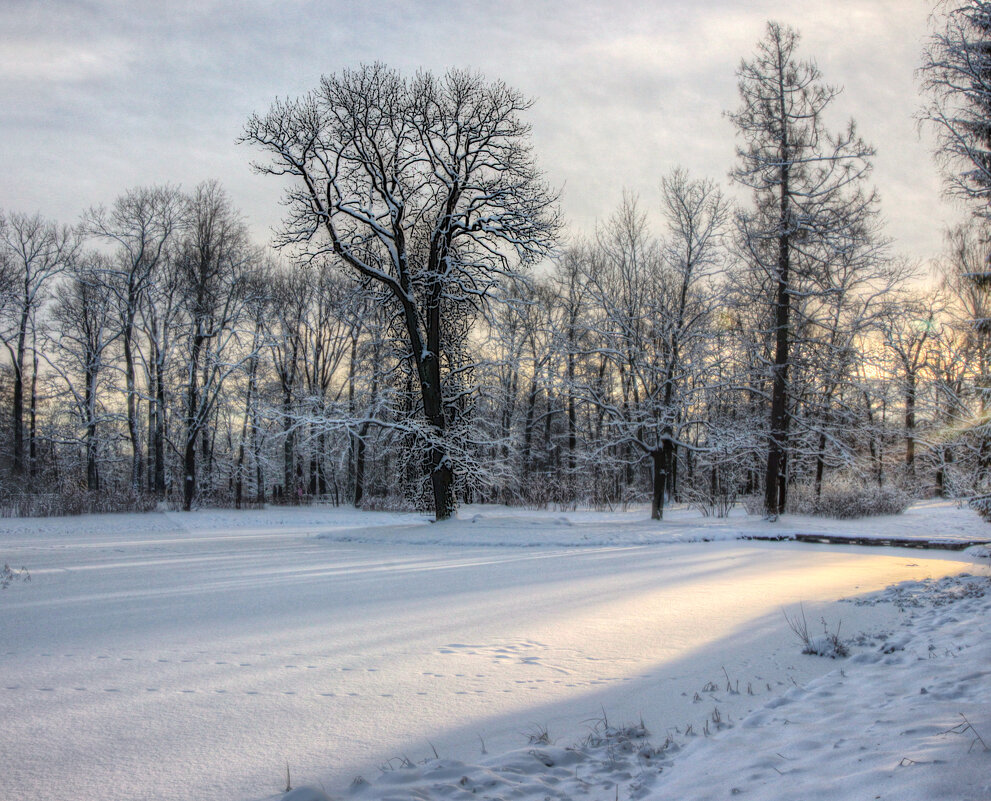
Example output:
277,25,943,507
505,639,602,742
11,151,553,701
572,177,727,520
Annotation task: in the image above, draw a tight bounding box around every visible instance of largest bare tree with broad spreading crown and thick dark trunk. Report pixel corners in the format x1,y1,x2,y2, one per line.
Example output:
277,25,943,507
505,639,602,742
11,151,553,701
243,64,557,519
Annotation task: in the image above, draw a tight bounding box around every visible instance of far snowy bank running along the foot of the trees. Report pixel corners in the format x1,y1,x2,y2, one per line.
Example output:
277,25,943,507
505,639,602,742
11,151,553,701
0,500,991,548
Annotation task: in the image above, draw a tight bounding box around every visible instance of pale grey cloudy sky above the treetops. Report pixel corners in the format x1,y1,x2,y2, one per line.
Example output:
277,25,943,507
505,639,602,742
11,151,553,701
0,0,962,259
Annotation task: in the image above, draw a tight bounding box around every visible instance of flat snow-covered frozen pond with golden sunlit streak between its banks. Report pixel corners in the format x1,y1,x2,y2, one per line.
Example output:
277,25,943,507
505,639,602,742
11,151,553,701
0,513,970,801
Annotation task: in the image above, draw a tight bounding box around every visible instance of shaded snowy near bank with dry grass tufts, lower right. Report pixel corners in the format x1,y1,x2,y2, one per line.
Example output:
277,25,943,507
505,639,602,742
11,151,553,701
283,575,991,801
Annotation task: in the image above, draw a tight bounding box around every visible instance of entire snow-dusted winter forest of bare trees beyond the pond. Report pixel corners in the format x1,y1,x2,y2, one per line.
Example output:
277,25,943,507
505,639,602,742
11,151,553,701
0,14,991,519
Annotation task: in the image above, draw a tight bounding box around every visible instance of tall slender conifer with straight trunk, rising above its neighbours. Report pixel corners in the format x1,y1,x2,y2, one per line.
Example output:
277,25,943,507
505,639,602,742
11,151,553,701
729,22,875,519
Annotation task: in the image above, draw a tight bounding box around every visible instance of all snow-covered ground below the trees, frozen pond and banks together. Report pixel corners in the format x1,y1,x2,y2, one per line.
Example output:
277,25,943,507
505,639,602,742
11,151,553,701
0,504,991,801
